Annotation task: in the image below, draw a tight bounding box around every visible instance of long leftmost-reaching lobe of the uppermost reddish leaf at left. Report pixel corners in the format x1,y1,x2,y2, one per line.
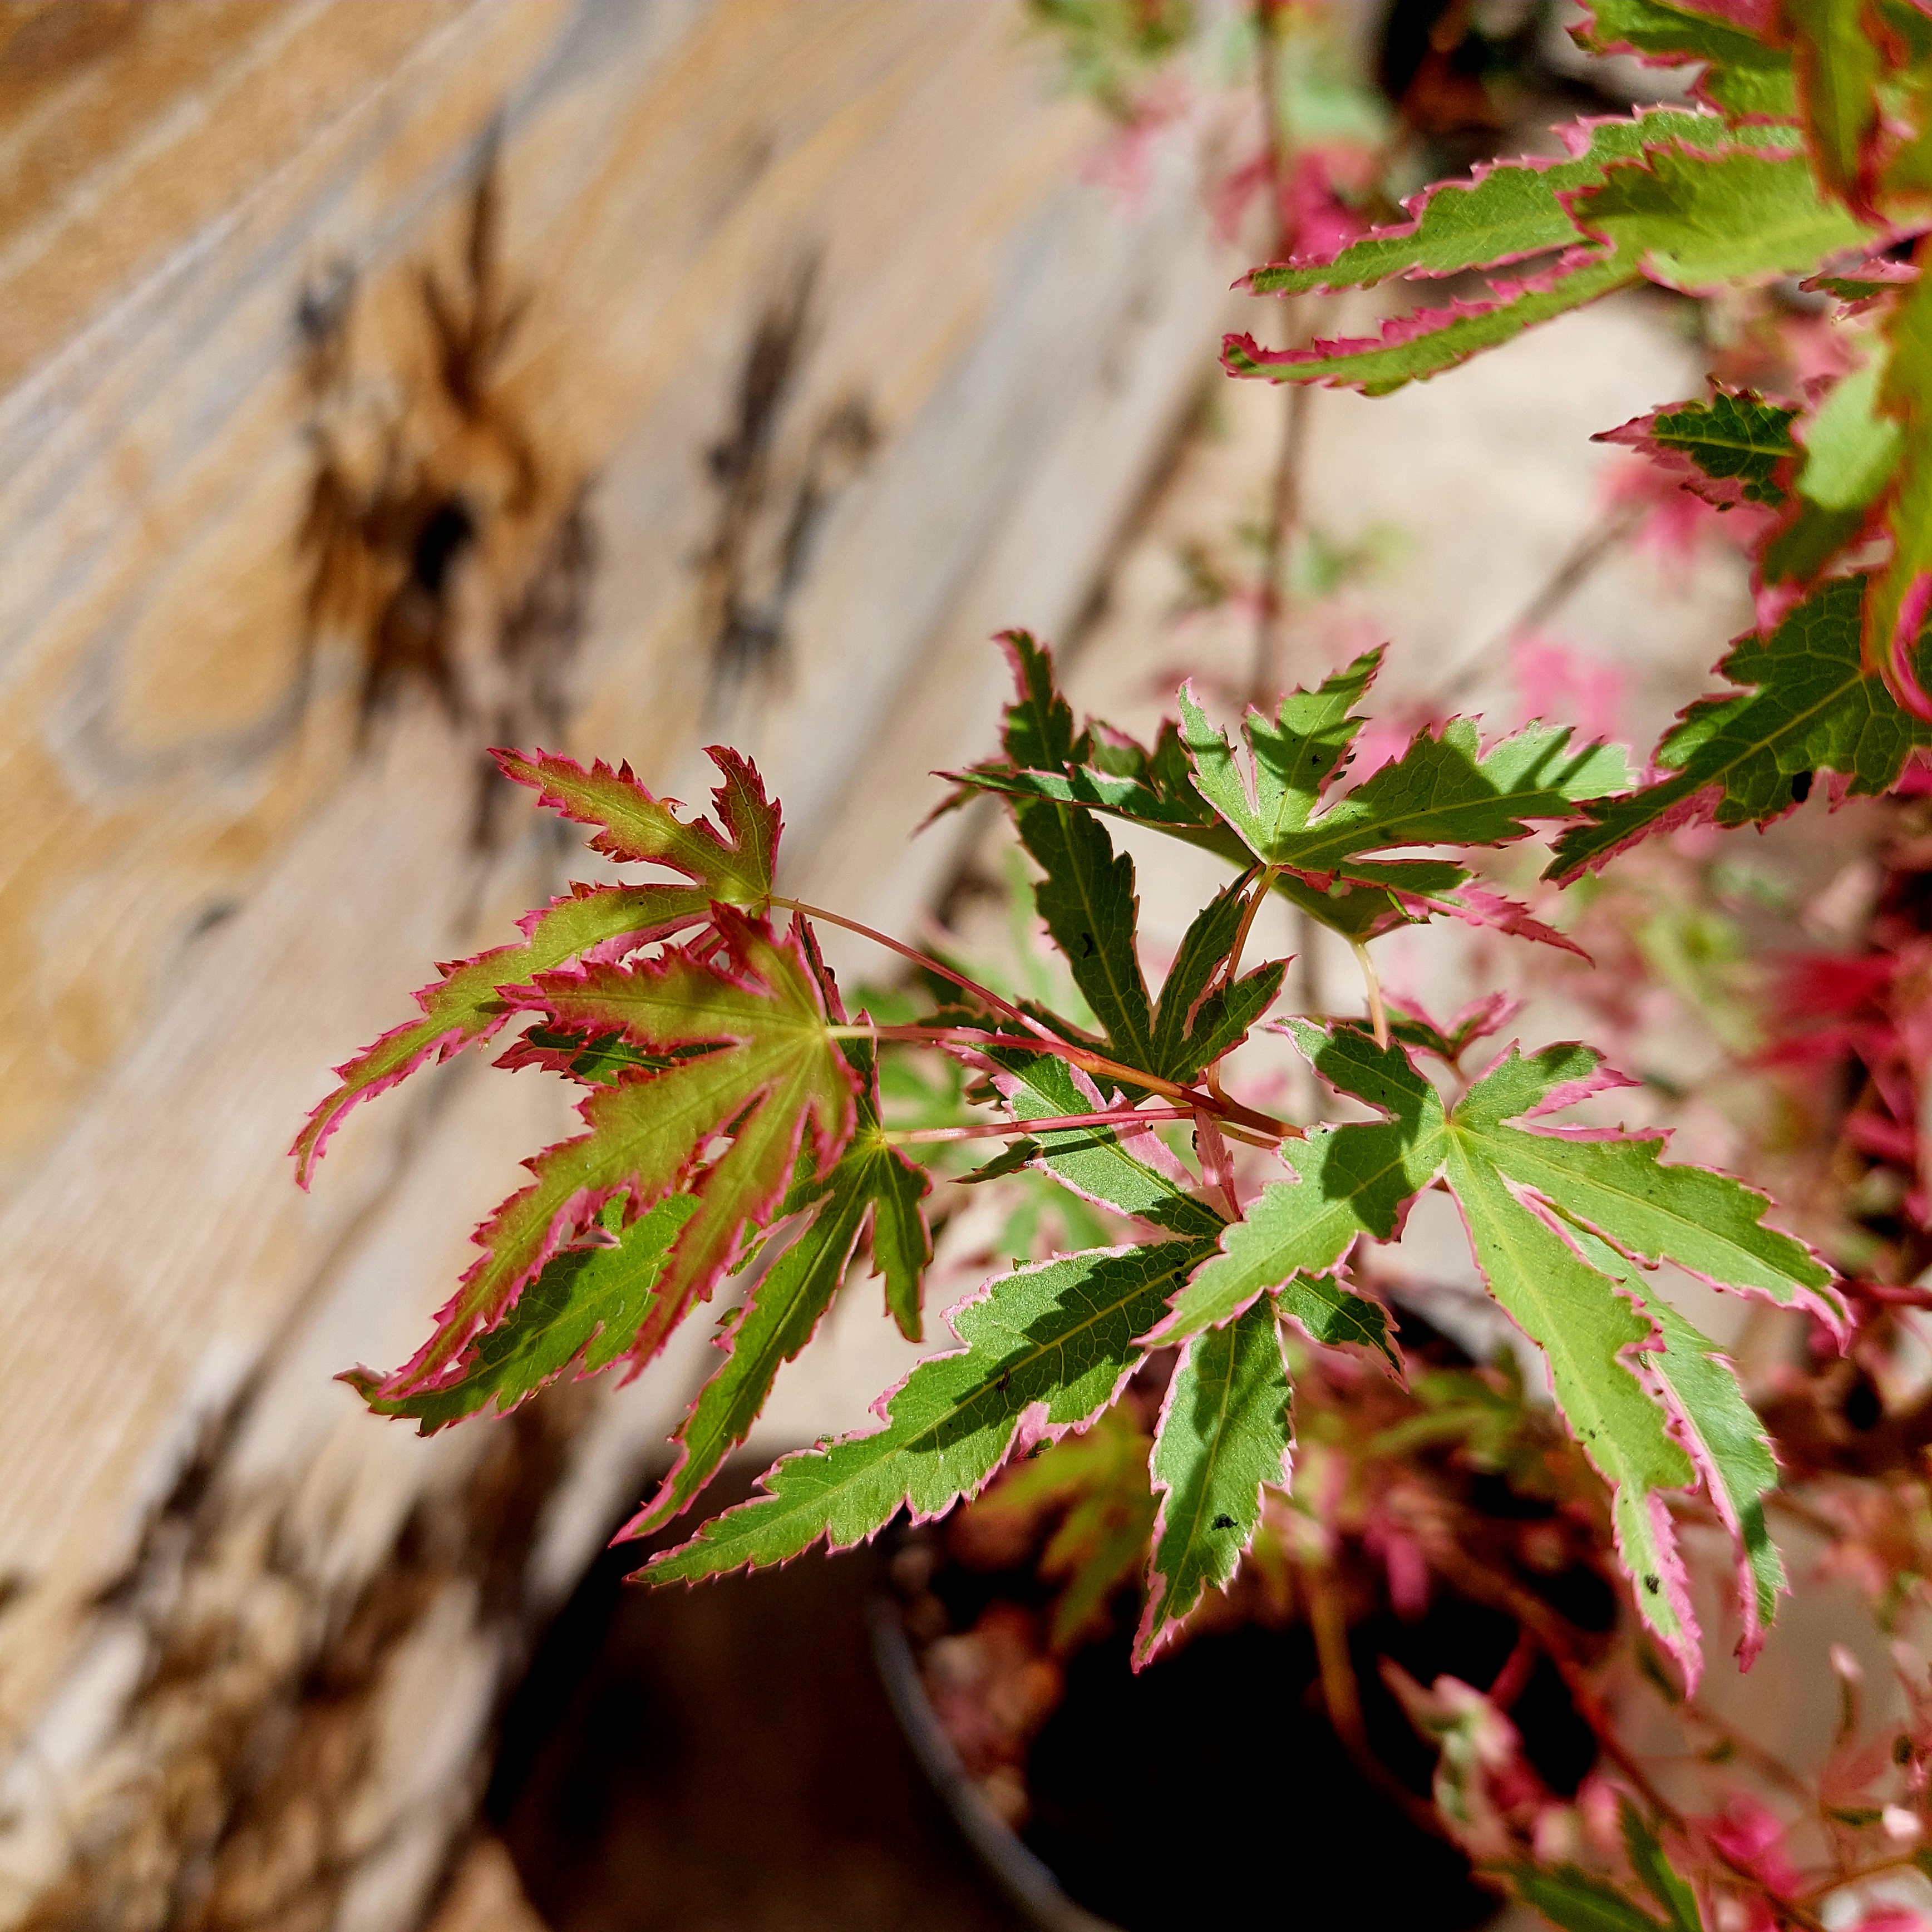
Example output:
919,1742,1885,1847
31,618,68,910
290,885,711,1186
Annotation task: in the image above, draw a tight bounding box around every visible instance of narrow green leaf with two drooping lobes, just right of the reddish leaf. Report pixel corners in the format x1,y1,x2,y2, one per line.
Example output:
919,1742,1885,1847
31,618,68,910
622,1041,933,1536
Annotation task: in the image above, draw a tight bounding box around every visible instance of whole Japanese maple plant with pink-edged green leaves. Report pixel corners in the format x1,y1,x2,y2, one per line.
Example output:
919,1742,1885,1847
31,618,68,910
295,0,1932,1932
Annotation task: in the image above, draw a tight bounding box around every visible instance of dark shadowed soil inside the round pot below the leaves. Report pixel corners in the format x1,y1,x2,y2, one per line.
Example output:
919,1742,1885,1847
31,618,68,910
895,1532,1609,1932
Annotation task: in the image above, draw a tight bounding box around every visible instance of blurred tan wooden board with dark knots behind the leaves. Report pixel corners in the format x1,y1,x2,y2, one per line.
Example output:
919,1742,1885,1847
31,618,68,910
0,0,1227,1928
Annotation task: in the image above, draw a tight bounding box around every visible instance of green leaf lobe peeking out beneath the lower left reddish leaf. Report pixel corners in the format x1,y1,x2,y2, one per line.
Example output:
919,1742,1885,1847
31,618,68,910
344,1194,697,1436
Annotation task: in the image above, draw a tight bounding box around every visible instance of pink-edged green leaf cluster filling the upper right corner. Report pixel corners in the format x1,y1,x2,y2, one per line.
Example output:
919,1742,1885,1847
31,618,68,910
1225,0,1932,875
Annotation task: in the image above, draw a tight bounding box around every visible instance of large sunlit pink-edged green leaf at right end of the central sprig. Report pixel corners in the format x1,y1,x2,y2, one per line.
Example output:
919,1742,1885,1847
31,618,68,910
1157,1022,1845,1677
